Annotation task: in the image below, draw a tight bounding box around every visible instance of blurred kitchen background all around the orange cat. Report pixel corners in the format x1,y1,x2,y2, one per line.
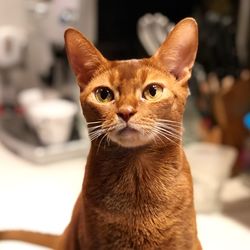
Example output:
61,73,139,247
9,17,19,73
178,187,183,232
0,0,250,250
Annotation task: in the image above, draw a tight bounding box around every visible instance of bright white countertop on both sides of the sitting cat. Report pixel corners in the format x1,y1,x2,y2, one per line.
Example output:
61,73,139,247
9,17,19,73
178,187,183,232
0,144,250,250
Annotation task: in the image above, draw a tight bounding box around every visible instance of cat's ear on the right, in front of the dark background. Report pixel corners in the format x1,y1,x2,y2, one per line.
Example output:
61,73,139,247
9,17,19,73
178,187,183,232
152,18,198,81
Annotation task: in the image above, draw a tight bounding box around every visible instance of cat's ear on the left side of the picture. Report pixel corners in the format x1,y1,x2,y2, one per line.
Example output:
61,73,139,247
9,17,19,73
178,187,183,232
64,28,107,90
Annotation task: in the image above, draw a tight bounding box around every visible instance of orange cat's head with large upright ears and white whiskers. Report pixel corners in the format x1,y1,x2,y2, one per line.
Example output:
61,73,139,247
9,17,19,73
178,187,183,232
65,18,198,147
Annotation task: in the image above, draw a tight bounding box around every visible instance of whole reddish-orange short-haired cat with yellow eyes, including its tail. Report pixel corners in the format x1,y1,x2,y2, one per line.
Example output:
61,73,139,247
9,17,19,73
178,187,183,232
0,18,202,250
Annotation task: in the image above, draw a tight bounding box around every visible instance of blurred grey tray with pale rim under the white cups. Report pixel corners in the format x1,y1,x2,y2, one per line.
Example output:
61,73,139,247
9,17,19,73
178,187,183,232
0,113,89,164
